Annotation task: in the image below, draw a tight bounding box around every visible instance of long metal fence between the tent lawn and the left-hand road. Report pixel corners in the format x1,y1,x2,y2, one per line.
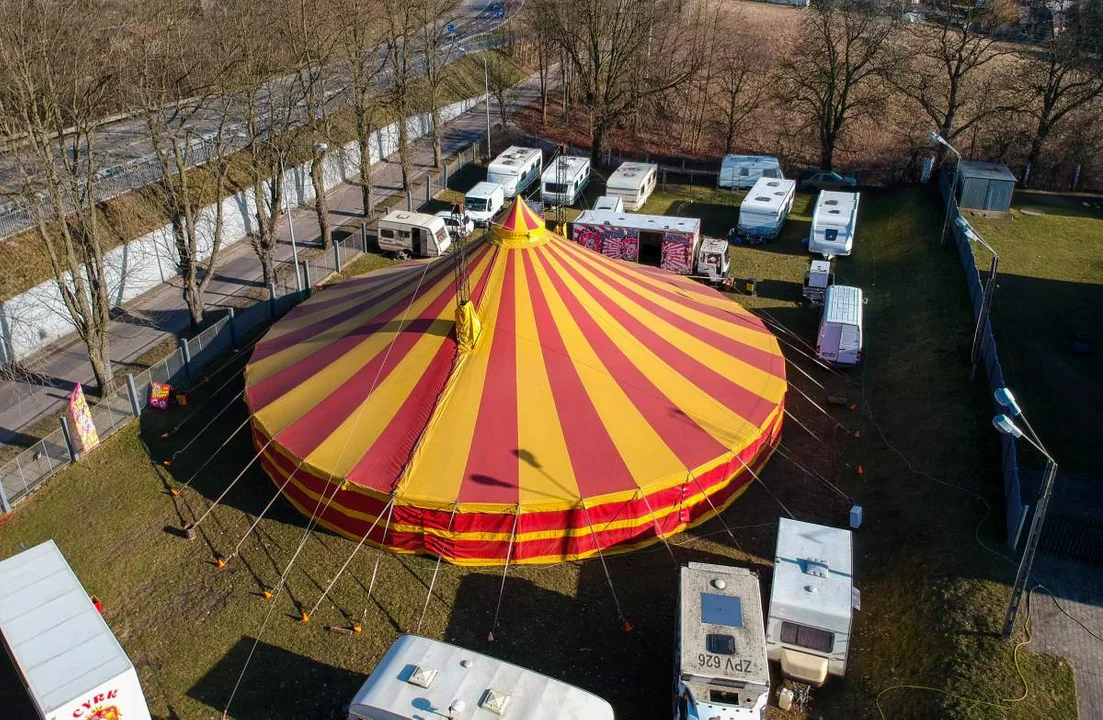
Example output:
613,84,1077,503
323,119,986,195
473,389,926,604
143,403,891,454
0,136,485,513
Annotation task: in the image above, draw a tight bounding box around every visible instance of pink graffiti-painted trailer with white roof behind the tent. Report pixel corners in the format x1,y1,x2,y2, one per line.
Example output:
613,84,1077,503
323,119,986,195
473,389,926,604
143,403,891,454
570,209,700,275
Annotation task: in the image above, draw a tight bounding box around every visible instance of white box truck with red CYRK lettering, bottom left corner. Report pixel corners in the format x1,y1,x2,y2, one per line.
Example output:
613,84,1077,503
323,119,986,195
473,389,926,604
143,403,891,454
0,540,150,720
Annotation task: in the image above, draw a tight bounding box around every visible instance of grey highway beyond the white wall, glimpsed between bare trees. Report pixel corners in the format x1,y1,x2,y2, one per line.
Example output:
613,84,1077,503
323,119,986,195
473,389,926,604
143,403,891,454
0,0,504,238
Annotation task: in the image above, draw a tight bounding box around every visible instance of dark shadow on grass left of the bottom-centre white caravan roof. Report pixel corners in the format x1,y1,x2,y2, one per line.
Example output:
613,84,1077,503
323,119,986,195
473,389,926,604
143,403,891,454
188,636,366,720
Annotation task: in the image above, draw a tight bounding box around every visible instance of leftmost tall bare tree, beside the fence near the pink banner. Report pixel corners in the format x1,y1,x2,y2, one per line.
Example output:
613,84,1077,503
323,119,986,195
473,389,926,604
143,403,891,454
0,0,117,395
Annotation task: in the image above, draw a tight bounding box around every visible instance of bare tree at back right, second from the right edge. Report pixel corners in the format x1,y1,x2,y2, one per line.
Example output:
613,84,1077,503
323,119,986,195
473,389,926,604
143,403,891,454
890,0,1017,159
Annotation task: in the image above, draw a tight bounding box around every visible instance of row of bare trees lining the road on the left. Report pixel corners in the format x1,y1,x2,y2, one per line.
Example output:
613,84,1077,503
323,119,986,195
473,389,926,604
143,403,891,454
0,0,469,391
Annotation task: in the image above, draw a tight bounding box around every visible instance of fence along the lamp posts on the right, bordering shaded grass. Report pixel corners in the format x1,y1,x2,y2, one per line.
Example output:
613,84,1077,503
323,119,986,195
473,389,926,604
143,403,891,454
949,205,1029,549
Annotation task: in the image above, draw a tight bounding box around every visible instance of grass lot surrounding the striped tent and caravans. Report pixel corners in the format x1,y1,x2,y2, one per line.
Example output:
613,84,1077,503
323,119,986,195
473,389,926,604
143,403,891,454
0,181,1077,719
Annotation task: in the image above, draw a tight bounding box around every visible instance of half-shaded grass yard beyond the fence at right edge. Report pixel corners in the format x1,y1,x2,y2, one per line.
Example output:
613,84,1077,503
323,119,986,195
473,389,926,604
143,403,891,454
970,193,1103,473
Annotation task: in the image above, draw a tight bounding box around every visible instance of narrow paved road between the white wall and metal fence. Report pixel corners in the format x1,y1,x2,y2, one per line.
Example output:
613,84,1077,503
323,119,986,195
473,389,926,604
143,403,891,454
0,72,539,454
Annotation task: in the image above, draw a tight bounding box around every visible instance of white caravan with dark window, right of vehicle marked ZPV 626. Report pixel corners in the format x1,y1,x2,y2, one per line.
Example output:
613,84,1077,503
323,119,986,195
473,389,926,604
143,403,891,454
765,517,859,687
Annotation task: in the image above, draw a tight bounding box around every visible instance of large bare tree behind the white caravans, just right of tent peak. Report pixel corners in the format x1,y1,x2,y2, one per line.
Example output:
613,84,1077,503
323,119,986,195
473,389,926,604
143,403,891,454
534,0,700,161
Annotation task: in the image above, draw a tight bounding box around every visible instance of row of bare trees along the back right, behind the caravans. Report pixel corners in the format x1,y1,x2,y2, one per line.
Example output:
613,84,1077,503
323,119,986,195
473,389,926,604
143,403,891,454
520,0,1103,176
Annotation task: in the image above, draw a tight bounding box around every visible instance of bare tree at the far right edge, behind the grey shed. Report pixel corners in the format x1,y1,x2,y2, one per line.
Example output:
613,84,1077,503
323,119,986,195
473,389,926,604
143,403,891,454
1018,0,1103,183
